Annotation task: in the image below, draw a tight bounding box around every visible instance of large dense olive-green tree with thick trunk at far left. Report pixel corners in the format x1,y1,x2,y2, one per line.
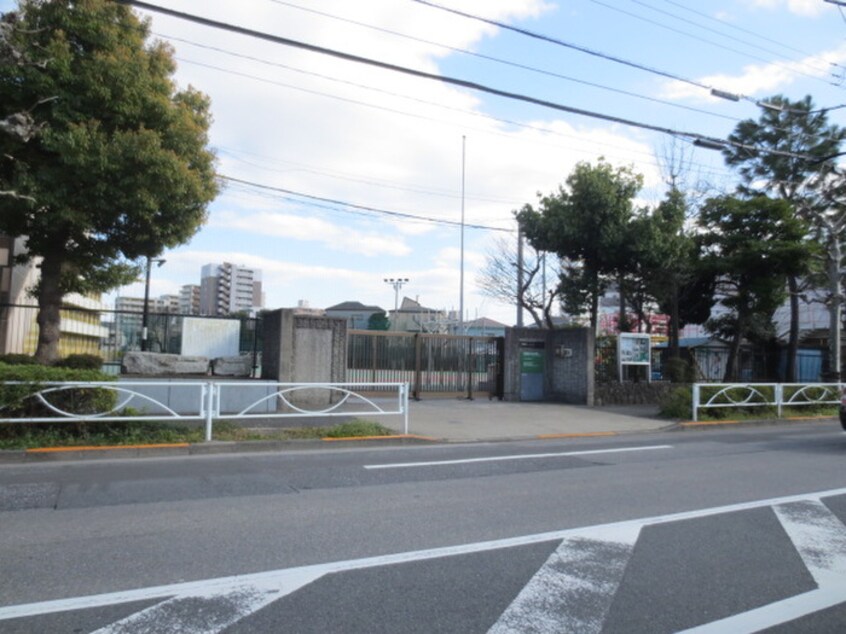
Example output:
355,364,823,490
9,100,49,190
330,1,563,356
0,0,217,361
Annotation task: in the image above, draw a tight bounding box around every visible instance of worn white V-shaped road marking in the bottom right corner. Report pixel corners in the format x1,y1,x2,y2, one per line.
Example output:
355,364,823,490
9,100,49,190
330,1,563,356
683,496,846,634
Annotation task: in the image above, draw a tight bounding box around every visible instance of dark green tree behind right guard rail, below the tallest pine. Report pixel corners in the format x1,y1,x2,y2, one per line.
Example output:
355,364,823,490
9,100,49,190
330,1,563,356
698,196,807,381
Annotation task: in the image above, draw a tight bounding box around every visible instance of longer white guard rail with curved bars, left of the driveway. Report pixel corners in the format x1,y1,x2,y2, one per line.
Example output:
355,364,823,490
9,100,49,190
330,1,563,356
0,380,409,441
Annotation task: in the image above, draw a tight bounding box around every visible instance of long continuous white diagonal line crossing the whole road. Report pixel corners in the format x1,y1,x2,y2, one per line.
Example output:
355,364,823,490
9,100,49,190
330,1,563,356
0,488,846,620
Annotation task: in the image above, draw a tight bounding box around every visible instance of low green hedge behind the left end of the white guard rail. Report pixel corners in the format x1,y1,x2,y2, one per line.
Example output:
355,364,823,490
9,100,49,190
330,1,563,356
0,363,117,418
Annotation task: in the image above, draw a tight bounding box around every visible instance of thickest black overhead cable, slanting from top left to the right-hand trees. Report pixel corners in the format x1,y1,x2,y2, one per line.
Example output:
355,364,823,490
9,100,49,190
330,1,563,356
115,0,820,161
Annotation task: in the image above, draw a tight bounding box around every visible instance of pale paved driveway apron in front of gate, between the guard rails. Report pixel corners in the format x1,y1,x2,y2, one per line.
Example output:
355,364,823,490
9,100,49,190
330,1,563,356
404,399,673,442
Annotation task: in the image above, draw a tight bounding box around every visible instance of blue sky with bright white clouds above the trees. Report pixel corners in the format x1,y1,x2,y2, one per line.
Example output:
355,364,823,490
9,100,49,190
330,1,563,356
0,0,846,325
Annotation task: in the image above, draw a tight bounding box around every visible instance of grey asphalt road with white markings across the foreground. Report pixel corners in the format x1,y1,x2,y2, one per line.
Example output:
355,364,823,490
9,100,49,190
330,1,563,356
0,423,846,634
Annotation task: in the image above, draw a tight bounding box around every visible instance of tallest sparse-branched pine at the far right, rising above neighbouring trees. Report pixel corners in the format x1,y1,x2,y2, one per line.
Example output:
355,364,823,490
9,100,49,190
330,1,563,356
723,95,846,381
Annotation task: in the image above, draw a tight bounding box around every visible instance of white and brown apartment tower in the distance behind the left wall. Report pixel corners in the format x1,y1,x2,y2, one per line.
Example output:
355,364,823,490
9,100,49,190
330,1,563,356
200,262,264,315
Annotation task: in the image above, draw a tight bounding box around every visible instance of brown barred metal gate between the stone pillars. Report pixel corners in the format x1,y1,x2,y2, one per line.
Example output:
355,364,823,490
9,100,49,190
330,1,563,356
347,330,505,400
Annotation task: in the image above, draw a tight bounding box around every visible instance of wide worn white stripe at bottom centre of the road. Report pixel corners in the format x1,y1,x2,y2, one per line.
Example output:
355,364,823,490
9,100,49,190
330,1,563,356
488,526,640,634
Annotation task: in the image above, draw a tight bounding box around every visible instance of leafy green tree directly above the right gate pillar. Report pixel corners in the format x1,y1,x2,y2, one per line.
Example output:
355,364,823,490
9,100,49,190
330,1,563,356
517,159,643,332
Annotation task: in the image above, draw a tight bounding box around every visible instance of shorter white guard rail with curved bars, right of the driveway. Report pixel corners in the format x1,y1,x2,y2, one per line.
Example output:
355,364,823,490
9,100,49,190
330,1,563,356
693,383,846,421
